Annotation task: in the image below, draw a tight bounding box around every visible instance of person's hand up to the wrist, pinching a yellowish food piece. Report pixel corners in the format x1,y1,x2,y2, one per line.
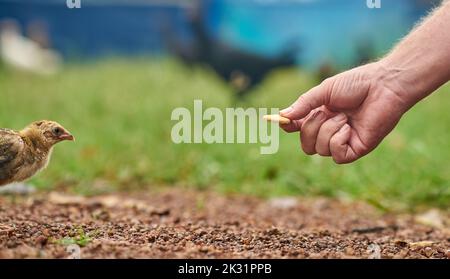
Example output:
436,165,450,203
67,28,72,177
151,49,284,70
280,62,413,164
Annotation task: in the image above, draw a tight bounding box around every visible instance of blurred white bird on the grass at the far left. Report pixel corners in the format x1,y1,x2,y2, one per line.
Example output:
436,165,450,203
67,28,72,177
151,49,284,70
0,20,61,75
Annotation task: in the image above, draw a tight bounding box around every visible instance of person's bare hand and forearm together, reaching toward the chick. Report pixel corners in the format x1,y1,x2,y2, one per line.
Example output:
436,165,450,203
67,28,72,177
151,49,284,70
280,1,450,164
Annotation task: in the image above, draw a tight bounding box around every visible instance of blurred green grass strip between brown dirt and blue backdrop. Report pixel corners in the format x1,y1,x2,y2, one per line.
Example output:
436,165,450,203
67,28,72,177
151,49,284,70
0,59,450,208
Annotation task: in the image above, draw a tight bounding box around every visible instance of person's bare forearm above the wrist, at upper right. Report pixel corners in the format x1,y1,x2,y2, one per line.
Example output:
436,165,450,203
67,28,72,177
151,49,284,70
379,1,450,106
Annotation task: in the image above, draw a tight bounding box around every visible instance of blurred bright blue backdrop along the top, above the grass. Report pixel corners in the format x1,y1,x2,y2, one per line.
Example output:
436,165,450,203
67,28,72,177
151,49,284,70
0,0,437,68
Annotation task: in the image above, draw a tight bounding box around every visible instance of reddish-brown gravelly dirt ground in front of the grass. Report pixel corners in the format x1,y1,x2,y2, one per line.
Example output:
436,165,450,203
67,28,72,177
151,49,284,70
0,190,450,258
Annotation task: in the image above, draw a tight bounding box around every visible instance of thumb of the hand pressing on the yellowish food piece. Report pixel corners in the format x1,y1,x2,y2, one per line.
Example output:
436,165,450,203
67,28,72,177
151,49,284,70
280,82,330,119
